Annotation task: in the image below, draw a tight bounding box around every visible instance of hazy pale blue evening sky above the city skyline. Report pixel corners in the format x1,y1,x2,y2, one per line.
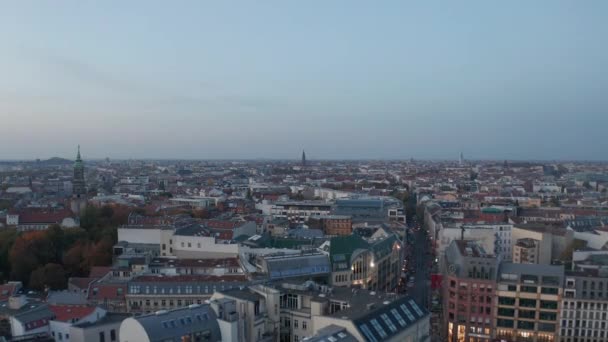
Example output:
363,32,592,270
0,0,608,160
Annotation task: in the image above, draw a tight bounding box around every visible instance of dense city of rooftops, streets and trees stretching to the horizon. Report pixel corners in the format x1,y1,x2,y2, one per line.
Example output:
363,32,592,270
0,147,608,342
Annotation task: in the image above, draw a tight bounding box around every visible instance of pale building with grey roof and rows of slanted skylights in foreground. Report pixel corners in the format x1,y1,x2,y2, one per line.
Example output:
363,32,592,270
210,281,429,342
